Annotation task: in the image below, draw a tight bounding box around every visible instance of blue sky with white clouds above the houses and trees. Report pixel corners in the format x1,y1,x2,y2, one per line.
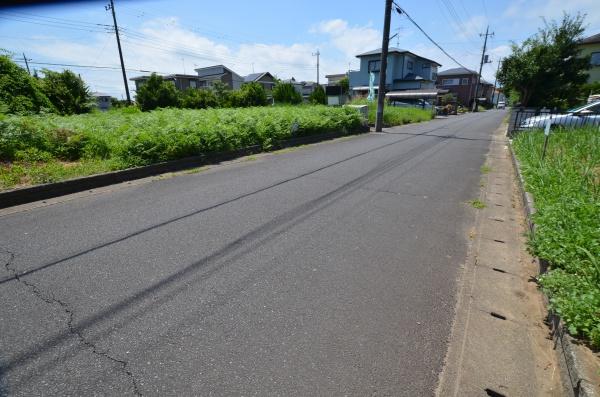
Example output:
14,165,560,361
0,0,600,97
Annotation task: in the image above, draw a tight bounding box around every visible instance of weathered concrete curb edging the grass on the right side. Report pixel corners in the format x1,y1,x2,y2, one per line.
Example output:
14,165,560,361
508,140,597,397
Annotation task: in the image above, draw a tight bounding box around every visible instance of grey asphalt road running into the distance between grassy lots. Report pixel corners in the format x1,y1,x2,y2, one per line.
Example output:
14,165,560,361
0,111,505,396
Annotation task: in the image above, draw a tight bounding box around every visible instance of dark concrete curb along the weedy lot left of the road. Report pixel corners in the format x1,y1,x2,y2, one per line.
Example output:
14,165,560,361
0,129,369,209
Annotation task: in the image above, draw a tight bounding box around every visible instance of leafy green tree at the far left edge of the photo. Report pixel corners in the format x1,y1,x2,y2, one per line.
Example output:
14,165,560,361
0,55,54,113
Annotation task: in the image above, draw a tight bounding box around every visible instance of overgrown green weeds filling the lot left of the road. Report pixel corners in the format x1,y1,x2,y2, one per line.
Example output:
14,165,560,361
0,106,363,189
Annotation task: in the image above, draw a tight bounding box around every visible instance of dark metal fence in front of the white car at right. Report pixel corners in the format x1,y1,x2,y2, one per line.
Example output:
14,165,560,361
508,108,600,135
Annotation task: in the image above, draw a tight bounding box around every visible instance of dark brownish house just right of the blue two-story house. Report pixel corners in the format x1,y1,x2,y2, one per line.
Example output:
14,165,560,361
437,68,494,107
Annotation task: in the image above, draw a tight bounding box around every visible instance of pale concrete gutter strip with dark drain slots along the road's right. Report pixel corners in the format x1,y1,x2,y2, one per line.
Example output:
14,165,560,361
437,124,564,396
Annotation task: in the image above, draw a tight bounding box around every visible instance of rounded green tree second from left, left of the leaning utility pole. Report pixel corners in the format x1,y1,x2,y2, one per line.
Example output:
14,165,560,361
41,69,94,114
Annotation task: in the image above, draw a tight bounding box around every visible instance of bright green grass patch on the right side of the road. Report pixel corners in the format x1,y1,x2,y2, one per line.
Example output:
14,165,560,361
514,128,600,347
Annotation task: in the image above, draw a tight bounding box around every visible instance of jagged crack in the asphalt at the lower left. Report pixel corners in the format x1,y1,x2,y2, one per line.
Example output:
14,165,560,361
1,249,142,396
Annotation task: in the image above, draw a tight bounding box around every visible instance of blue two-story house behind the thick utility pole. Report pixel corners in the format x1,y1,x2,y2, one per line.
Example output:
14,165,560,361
349,47,442,97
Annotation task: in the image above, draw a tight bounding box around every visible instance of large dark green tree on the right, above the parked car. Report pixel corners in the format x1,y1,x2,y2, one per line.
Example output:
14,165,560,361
497,14,589,108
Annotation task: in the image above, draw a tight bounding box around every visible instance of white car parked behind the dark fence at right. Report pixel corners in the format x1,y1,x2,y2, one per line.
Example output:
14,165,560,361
519,102,600,128
